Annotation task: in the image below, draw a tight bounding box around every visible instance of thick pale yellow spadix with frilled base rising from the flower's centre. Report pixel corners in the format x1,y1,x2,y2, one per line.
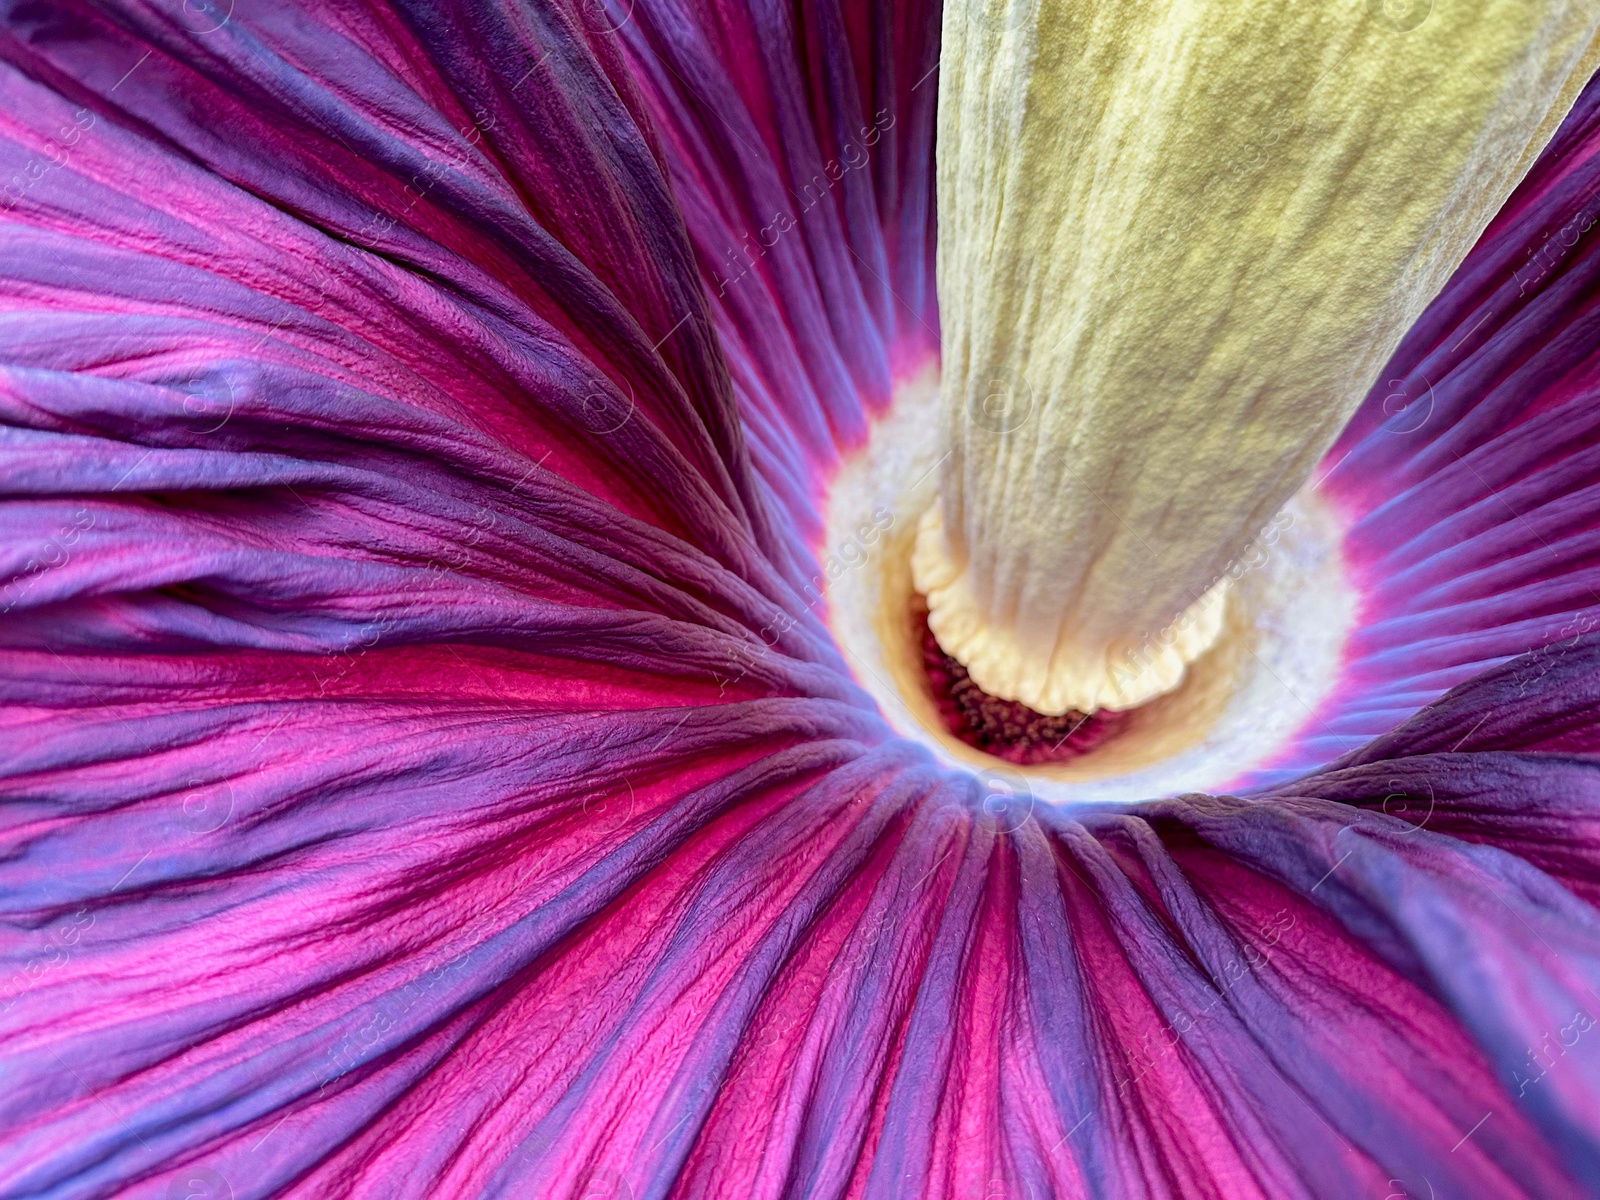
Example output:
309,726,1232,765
914,0,1600,712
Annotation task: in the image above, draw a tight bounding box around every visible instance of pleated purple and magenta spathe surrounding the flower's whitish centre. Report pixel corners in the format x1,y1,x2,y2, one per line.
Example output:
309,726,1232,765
0,0,1600,1200
